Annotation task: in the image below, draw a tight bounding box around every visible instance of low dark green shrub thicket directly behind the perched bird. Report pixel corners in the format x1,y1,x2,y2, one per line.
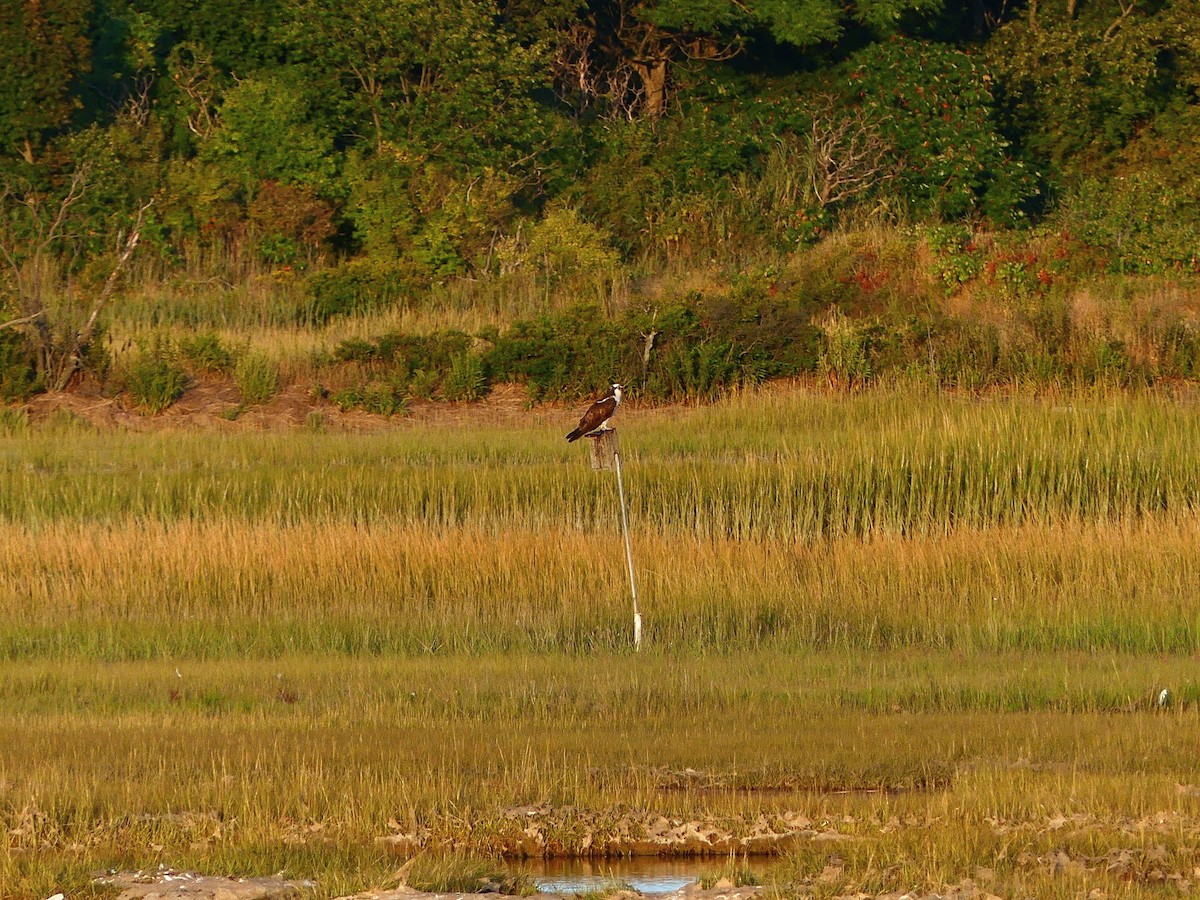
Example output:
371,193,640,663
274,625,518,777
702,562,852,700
324,289,820,401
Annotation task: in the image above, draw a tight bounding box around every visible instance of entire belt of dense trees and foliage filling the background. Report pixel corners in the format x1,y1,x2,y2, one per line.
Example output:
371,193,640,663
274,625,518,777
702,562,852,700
0,0,1200,303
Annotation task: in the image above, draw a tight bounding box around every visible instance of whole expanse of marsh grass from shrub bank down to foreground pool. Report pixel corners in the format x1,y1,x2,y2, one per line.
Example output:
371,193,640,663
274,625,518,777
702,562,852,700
7,391,1200,900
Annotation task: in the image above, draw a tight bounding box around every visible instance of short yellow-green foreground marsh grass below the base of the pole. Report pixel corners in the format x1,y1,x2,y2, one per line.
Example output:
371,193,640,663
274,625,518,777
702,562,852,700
7,653,1200,896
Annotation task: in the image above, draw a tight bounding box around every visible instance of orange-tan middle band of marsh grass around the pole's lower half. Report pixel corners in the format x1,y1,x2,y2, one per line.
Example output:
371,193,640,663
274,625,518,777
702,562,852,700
7,516,1200,660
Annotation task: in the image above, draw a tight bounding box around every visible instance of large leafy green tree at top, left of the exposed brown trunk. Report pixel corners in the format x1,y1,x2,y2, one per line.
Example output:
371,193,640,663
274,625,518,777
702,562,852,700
288,0,564,178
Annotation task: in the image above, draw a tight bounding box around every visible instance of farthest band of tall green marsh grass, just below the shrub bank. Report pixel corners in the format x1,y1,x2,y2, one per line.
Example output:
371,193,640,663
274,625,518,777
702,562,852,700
0,392,1200,541
